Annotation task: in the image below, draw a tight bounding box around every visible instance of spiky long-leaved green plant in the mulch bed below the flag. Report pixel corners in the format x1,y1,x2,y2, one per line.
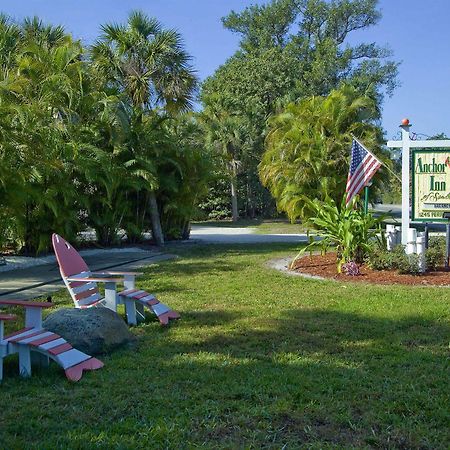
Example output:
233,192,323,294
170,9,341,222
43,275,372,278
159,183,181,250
293,198,384,273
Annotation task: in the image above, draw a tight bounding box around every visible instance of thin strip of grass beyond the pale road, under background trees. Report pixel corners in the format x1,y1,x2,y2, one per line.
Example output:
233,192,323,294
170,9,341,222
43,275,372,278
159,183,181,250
194,219,307,234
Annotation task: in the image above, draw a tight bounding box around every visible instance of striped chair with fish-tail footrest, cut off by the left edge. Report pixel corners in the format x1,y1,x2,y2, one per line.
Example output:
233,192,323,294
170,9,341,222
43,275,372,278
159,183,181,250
0,300,103,381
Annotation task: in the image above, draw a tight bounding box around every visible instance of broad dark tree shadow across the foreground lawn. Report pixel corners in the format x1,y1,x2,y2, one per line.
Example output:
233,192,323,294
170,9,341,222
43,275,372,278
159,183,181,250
0,310,450,448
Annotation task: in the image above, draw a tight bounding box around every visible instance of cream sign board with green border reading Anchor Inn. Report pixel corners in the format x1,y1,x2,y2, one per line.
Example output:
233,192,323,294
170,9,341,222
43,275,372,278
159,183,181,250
411,149,450,222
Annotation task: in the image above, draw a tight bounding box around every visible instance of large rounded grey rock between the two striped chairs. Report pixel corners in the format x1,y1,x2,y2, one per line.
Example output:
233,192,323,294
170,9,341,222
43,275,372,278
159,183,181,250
43,308,136,355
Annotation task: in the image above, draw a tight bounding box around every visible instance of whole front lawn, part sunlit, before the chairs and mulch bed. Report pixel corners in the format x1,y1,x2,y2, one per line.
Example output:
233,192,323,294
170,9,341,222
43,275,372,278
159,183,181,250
0,245,450,449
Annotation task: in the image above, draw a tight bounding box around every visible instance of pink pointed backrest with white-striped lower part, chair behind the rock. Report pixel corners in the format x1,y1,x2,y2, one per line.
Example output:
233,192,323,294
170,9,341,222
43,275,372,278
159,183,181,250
52,233,102,308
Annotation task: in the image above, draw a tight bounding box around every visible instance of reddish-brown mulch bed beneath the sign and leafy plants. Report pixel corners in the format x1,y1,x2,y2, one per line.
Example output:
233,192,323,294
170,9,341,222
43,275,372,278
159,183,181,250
293,253,450,286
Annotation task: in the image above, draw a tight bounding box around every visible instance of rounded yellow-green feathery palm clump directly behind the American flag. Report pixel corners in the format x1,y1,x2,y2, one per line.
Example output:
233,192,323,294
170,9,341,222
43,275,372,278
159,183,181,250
259,86,389,221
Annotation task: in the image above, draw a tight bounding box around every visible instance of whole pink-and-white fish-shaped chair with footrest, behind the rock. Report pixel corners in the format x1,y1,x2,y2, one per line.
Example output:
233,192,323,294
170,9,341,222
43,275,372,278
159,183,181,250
52,234,180,325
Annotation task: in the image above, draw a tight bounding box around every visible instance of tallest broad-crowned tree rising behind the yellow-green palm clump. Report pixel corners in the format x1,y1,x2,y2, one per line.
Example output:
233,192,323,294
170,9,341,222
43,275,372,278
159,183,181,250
201,0,397,219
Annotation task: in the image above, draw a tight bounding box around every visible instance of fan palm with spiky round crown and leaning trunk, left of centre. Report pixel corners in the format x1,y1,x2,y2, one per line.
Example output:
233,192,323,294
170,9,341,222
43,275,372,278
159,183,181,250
91,11,197,245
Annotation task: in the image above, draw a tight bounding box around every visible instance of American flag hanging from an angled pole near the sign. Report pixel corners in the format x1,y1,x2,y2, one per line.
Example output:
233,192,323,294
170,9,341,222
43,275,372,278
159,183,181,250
345,139,381,205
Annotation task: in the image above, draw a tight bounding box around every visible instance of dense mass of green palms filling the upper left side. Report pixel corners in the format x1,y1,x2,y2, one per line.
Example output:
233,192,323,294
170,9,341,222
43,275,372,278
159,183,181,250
0,12,209,253
